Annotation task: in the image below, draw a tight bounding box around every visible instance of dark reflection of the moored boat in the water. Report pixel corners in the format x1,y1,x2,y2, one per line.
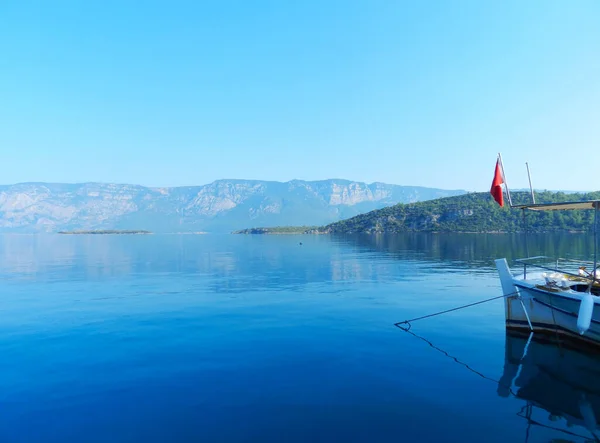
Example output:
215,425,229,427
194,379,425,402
498,330,600,441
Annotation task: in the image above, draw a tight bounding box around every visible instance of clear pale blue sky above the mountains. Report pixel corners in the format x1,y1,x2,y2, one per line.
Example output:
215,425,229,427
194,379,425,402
0,0,600,190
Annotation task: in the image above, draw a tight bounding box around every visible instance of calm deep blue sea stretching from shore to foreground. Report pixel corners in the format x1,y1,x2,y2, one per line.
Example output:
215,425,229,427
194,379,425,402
0,235,600,443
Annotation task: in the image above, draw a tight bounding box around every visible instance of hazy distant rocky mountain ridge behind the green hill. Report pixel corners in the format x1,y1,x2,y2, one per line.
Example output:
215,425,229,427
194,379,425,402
0,179,466,232
